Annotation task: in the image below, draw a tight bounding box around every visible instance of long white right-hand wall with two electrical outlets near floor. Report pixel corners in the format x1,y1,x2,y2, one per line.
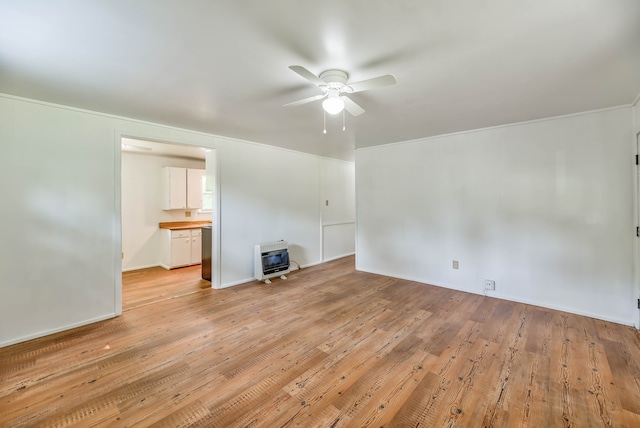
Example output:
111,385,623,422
356,108,636,324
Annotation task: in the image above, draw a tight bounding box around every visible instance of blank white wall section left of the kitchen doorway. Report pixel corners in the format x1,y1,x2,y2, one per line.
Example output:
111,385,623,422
0,98,117,345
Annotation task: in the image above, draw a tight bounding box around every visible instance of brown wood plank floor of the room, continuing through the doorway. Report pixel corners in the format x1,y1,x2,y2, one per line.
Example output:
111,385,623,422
0,257,640,427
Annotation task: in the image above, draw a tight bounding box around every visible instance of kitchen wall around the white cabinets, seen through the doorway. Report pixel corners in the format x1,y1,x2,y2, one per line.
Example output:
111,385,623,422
121,152,206,271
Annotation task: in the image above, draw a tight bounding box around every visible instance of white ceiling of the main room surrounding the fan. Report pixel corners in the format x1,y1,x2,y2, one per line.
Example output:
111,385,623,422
0,0,640,160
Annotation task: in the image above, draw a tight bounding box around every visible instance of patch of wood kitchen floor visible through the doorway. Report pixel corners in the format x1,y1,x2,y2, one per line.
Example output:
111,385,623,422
122,265,211,311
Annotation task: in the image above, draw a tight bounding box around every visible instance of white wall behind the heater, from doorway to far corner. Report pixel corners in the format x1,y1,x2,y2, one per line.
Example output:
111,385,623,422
221,145,355,286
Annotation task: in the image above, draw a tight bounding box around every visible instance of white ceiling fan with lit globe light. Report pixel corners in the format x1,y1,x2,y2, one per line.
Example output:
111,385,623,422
284,65,396,116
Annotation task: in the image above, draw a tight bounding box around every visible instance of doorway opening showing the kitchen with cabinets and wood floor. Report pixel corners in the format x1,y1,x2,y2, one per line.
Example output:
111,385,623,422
116,135,219,311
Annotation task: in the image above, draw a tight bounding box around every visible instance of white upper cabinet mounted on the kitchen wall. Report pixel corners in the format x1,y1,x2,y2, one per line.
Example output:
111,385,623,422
162,166,205,210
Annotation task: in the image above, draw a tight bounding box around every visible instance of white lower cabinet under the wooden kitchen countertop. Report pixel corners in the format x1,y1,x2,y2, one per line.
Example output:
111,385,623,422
161,228,202,269
